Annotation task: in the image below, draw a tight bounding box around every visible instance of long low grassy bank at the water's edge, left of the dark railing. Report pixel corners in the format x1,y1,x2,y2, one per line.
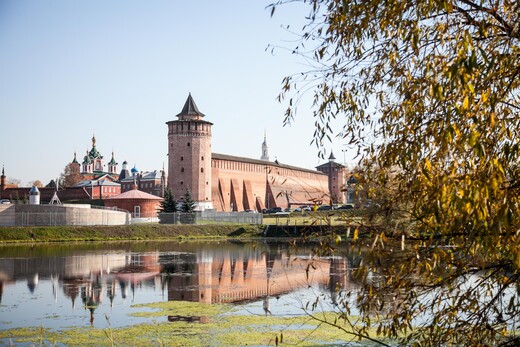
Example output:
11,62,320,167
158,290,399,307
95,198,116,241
0,224,265,243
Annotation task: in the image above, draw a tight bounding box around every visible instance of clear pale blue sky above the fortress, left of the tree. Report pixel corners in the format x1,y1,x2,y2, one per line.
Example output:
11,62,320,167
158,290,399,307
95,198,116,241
0,0,353,185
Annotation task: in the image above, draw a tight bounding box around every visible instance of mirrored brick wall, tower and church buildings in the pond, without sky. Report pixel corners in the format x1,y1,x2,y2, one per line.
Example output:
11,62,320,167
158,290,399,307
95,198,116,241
0,250,349,324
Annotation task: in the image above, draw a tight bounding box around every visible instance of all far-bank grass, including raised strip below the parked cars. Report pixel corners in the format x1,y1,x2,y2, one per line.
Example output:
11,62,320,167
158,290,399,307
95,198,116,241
0,211,374,243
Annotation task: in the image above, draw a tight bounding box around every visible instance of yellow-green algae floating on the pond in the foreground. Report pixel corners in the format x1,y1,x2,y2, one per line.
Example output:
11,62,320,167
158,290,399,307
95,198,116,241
0,301,390,346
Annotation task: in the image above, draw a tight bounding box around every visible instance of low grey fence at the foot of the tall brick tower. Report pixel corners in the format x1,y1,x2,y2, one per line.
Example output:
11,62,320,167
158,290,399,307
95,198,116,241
159,211,263,224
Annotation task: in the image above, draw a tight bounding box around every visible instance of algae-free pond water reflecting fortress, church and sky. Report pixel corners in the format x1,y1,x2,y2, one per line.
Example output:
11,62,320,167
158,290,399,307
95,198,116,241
0,242,354,329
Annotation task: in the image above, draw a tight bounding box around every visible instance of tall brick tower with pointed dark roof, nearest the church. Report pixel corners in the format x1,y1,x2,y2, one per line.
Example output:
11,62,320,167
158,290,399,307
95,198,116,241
166,94,213,210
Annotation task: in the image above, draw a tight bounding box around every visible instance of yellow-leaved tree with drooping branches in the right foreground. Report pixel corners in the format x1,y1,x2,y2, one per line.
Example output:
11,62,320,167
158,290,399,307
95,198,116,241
271,0,520,346
